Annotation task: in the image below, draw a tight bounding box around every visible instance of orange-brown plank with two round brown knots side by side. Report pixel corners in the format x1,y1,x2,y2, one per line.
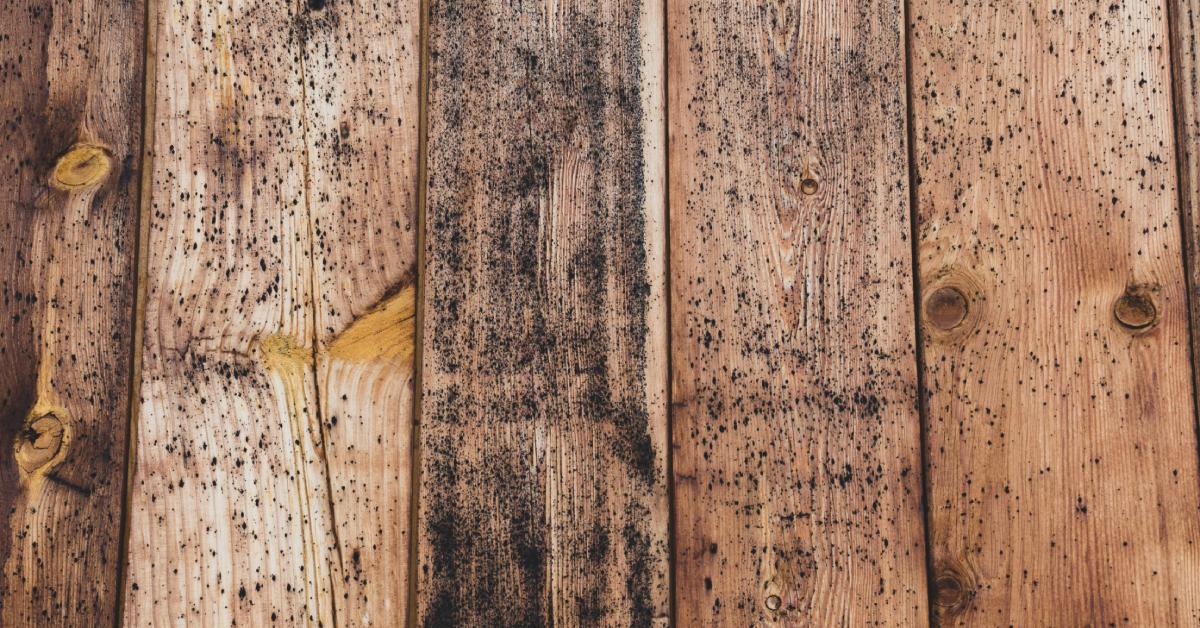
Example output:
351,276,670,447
910,0,1200,626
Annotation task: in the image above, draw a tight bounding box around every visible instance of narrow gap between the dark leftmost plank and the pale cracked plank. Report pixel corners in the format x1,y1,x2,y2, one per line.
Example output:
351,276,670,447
113,0,158,628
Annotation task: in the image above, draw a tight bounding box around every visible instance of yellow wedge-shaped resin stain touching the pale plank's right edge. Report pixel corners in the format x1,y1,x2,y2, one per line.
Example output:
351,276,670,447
329,285,416,363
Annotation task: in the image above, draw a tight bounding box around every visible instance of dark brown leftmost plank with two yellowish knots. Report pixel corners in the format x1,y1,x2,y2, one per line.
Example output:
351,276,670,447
0,0,143,626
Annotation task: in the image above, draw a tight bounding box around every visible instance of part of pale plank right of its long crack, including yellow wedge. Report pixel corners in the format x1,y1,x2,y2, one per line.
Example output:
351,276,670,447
304,0,421,626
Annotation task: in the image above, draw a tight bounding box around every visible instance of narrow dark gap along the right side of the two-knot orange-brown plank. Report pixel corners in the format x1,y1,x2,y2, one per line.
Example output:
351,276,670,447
1164,0,1200,511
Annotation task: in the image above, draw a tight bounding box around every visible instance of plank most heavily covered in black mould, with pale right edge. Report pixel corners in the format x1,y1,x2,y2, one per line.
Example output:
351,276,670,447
416,0,668,626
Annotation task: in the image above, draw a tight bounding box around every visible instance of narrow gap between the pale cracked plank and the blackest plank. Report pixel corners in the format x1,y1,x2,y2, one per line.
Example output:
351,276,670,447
404,0,432,628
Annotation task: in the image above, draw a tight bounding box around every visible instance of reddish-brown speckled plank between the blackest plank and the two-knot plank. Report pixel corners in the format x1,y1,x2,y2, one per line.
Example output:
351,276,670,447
668,0,928,626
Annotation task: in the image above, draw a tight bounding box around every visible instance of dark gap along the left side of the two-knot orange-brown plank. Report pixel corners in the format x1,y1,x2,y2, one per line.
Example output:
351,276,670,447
900,0,937,626
